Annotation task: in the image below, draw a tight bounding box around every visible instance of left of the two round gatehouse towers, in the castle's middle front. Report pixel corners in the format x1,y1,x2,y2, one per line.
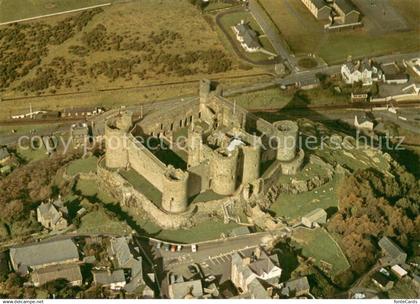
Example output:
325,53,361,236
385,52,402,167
210,149,239,195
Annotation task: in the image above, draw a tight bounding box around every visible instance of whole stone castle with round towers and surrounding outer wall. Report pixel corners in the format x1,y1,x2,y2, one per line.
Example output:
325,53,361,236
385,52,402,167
98,80,304,229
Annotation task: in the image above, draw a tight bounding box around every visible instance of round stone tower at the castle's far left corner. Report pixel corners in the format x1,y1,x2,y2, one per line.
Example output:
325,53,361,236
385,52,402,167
105,112,132,169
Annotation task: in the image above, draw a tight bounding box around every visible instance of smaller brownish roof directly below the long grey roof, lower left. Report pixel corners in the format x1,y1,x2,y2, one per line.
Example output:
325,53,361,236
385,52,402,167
32,265,83,286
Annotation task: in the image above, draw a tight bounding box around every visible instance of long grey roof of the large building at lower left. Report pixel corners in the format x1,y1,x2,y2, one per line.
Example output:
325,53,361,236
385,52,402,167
10,239,79,270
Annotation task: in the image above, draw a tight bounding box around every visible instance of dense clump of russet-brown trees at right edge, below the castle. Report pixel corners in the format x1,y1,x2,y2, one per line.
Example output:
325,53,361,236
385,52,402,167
328,168,420,274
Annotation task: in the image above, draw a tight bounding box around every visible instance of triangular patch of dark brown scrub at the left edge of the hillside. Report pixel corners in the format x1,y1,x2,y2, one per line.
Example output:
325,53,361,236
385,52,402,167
0,9,102,89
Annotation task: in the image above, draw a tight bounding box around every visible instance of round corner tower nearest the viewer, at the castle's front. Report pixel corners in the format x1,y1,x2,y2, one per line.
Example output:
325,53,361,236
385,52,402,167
162,166,188,213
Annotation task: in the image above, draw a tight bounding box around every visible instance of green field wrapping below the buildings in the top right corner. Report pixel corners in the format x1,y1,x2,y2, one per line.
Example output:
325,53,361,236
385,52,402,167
260,0,420,64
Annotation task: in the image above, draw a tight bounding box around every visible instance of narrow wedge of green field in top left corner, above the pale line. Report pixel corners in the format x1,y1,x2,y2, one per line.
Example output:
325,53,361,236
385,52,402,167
0,0,113,23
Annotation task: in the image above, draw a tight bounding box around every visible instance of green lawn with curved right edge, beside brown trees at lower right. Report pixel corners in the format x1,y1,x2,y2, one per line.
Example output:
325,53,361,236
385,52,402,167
293,228,350,276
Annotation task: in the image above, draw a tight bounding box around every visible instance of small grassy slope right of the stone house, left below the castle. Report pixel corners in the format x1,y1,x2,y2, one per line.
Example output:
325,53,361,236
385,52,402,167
77,208,131,235
